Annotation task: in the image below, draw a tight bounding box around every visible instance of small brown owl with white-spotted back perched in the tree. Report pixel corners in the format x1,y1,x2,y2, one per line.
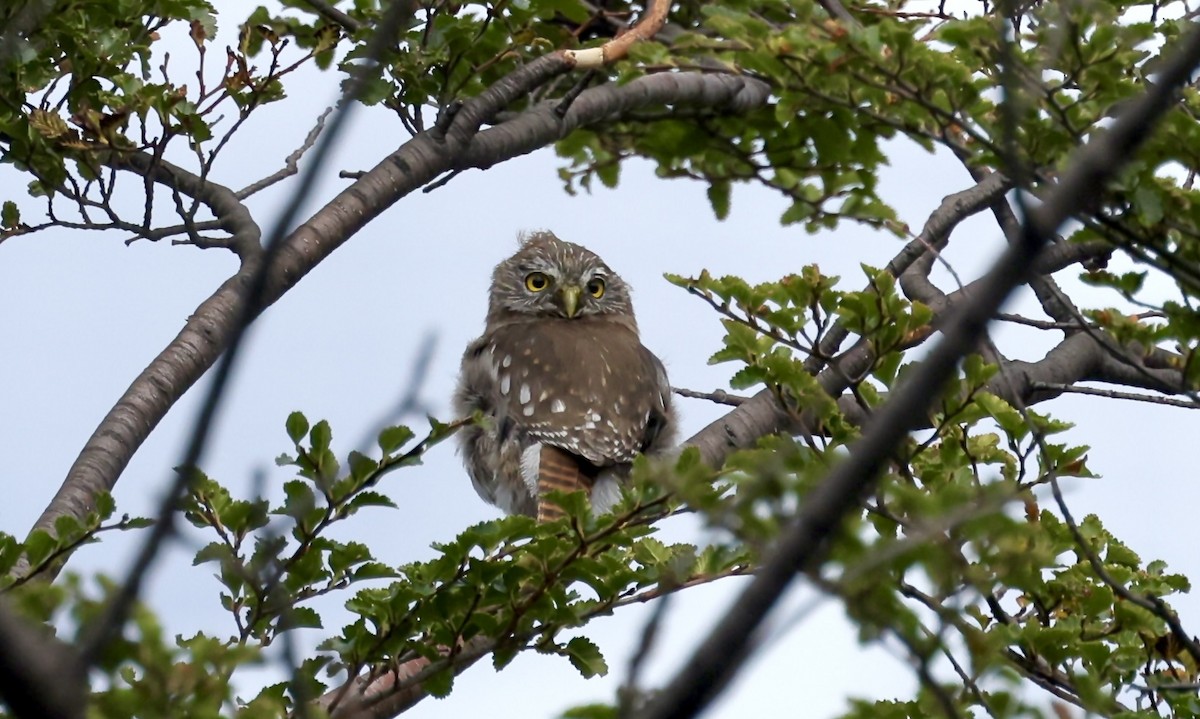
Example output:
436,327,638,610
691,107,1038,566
455,232,674,521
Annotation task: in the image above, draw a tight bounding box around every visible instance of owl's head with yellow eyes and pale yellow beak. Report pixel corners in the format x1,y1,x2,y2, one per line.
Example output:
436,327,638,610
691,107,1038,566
487,232,634,324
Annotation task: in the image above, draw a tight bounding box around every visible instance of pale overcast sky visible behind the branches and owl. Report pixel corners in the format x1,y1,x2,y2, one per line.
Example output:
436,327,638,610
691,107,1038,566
0,1,1200,719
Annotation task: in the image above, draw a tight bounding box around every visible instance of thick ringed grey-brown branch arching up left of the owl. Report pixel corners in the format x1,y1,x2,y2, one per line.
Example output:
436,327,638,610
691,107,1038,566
18,69,767,575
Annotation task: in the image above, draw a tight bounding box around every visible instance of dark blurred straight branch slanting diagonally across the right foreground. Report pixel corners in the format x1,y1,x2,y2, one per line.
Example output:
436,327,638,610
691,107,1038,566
638,22,1200,719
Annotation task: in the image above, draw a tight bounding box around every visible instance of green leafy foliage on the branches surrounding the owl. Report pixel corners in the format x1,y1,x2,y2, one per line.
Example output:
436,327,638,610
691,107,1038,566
0,0,1200,718
